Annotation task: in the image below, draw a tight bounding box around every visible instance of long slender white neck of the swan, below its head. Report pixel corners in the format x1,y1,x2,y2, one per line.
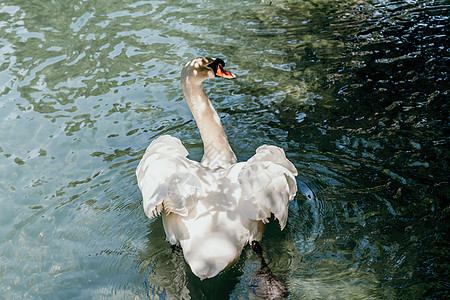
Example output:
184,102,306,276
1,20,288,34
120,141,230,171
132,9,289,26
181,76,237,168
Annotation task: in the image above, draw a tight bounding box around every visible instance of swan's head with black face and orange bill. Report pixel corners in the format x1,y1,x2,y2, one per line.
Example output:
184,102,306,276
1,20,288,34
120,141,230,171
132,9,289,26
181,57,236,83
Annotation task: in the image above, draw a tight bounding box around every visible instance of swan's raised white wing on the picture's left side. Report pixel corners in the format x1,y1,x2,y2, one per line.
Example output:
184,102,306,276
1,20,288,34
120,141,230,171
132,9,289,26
136,135,202,218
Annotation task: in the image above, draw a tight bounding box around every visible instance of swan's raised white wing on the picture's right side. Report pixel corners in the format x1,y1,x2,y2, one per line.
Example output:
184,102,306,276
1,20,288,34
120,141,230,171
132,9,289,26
239,145,297,229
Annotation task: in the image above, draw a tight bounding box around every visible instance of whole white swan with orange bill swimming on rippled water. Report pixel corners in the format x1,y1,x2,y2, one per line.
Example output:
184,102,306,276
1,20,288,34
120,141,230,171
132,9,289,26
136,57,297,280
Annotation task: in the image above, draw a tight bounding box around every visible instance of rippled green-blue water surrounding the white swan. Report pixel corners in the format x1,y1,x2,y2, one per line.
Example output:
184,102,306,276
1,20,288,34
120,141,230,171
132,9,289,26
0,0,449,299
